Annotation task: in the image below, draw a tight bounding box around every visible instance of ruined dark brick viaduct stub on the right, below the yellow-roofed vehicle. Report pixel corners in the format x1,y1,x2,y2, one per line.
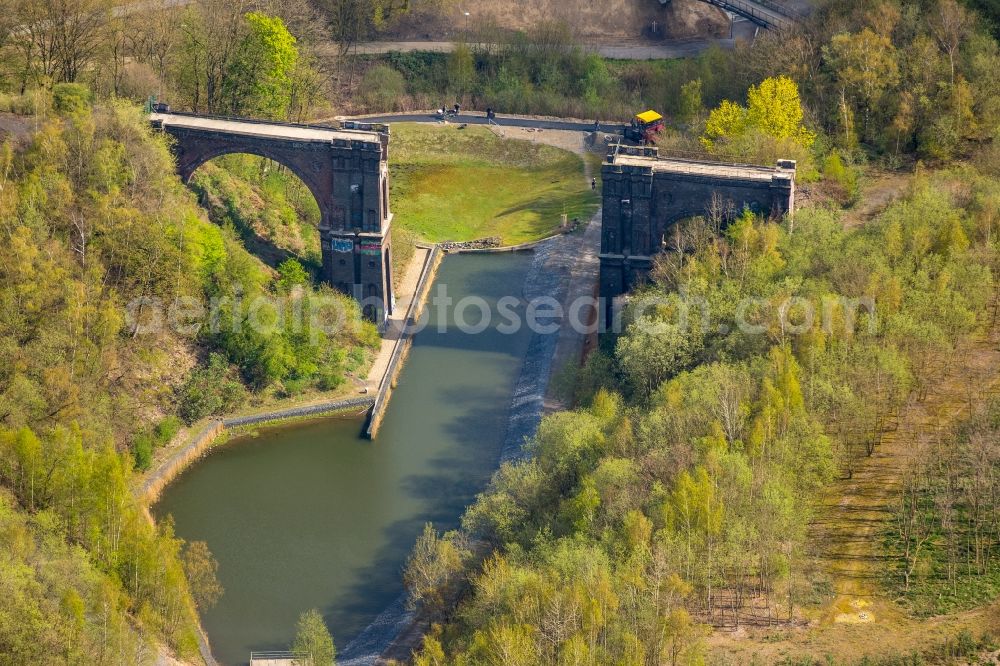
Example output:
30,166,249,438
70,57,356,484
600,146,795,312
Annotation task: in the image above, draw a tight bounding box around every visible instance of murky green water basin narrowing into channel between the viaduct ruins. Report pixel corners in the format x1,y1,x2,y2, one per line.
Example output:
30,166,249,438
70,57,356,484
154,254,532,664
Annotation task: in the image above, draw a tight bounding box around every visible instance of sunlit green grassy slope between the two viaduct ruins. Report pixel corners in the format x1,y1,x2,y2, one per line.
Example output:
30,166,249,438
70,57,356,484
389,123,598,245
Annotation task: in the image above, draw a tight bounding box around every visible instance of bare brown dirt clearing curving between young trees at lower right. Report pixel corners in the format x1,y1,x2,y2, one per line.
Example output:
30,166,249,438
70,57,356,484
710,322,1000,663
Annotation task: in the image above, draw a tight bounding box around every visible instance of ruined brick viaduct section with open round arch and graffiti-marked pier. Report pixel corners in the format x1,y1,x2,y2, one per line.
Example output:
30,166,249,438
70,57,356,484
150,113,394,327
